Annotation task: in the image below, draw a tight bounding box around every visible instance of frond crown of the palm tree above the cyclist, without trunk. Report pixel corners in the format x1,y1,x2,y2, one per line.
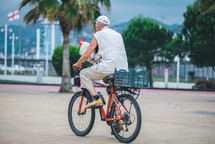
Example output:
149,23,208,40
20,0,111,32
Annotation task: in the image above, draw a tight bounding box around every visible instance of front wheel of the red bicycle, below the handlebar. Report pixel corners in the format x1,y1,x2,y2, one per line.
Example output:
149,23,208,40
68,91,95,136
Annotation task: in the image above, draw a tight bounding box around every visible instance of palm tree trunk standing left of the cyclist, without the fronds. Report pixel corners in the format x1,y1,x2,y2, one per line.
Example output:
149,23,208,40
59,31,72,92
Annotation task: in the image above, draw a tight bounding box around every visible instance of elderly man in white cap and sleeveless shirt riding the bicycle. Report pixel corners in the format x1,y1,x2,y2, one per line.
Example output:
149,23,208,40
73,16,128,108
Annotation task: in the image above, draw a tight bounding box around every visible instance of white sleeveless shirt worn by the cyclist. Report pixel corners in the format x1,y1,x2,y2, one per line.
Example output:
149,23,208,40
91,27,128,73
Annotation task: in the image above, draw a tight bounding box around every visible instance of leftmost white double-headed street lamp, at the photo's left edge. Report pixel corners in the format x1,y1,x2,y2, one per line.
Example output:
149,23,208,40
1,24,12,76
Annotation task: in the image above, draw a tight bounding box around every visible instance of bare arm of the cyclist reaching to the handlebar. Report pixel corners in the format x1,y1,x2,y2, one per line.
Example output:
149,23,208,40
73,37,98,70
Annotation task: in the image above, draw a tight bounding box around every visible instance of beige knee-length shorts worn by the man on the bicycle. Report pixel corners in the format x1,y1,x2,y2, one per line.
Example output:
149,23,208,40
80,68,113,89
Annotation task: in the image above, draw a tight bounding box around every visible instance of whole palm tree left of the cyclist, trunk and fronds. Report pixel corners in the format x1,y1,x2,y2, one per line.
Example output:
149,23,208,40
19,0,111,92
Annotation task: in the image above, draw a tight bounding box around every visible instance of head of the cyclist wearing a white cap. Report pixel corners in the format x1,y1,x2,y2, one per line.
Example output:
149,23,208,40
96,16,110,31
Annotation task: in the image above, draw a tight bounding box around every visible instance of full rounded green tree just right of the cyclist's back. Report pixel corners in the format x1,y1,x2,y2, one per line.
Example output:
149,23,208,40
123,17,174,87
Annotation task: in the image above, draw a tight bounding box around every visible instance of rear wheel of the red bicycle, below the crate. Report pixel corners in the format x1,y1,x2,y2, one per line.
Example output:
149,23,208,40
110,94,141,143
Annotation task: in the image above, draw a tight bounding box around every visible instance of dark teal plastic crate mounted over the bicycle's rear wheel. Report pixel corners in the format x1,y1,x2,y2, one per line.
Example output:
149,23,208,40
114,69,149,88
